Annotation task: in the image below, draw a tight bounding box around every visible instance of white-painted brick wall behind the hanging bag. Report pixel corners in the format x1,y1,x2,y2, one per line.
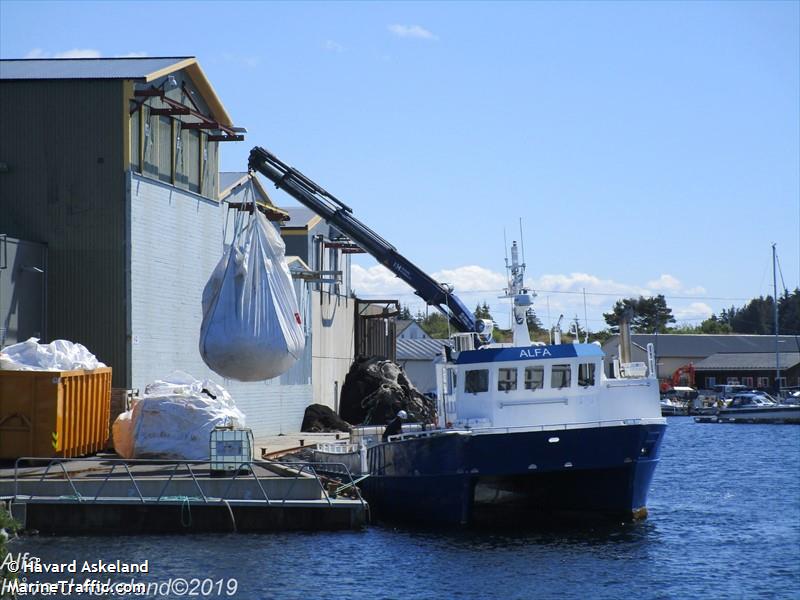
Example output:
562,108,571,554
130,175,313,436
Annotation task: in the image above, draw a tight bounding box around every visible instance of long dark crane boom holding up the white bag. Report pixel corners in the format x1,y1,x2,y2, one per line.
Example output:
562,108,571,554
249,146,476,333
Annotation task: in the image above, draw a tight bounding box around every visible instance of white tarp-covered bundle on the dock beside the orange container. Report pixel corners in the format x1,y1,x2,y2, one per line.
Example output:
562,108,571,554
112,371,245,460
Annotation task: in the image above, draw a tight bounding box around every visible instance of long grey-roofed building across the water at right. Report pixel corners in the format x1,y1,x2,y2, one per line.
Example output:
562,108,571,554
603,333,800,389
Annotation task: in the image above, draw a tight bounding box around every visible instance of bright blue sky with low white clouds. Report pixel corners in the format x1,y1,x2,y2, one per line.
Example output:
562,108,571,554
0,0,800,330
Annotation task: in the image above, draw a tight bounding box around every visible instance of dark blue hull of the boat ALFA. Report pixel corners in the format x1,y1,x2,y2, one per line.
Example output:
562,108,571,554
362,425,666,525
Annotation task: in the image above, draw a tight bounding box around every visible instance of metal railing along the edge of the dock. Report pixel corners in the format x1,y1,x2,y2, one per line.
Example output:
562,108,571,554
13,456,365,506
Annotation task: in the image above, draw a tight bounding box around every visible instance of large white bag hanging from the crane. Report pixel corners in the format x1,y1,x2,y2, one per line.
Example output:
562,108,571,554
200,210,305,381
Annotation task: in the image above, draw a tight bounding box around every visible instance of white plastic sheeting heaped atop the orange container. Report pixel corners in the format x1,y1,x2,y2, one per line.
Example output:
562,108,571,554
0,338,106,371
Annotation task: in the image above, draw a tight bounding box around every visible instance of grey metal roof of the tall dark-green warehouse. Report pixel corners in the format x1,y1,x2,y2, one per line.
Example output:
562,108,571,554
0,56,192,79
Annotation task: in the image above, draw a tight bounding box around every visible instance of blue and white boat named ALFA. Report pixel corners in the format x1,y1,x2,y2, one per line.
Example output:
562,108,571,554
327,243,666,526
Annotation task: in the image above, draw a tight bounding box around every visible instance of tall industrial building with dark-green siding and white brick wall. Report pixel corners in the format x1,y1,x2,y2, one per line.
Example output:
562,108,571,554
0,57,372,435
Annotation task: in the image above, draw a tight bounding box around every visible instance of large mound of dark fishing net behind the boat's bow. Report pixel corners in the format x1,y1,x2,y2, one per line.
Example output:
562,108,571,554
339,357,436,425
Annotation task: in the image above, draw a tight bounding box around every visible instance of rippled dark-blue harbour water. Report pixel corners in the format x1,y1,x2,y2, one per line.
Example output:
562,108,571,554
7,417,800,600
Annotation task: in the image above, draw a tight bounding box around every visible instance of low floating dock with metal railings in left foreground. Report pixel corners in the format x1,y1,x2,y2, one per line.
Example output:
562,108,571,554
0,457,369,535
